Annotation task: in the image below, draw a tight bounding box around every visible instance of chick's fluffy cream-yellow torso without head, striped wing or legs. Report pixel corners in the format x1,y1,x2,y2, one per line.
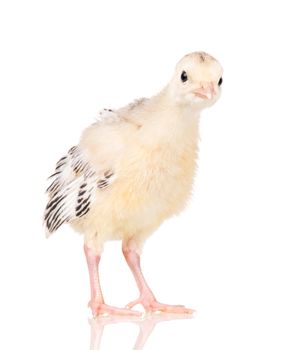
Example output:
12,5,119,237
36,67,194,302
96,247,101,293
72,93,199,245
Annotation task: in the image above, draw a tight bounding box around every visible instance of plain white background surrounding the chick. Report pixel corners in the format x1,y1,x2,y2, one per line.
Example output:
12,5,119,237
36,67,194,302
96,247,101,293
0,0,282,350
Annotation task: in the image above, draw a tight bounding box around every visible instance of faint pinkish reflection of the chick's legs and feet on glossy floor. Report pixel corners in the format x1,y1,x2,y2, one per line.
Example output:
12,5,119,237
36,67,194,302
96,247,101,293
89,313,193,350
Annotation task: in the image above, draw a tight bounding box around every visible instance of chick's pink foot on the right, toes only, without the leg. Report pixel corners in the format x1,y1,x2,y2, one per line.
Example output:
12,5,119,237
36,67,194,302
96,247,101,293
126,296,195,315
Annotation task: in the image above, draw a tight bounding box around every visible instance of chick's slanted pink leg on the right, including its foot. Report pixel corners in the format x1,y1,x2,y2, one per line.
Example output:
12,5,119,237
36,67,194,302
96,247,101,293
122,241,194,314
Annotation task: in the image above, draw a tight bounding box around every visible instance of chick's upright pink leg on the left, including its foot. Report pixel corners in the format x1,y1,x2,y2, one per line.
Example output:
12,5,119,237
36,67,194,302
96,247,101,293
84,245,141,316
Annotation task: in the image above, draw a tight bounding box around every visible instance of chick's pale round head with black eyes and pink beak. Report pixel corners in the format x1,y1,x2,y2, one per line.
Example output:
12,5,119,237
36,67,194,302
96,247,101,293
168,52,223,109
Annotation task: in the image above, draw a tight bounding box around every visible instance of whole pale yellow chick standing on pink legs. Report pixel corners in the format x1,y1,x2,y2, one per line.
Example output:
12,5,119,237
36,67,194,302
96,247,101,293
44,52,222,315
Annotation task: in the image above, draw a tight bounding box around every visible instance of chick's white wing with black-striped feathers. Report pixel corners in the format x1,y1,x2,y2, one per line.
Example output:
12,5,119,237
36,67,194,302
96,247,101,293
44,146,114,236
